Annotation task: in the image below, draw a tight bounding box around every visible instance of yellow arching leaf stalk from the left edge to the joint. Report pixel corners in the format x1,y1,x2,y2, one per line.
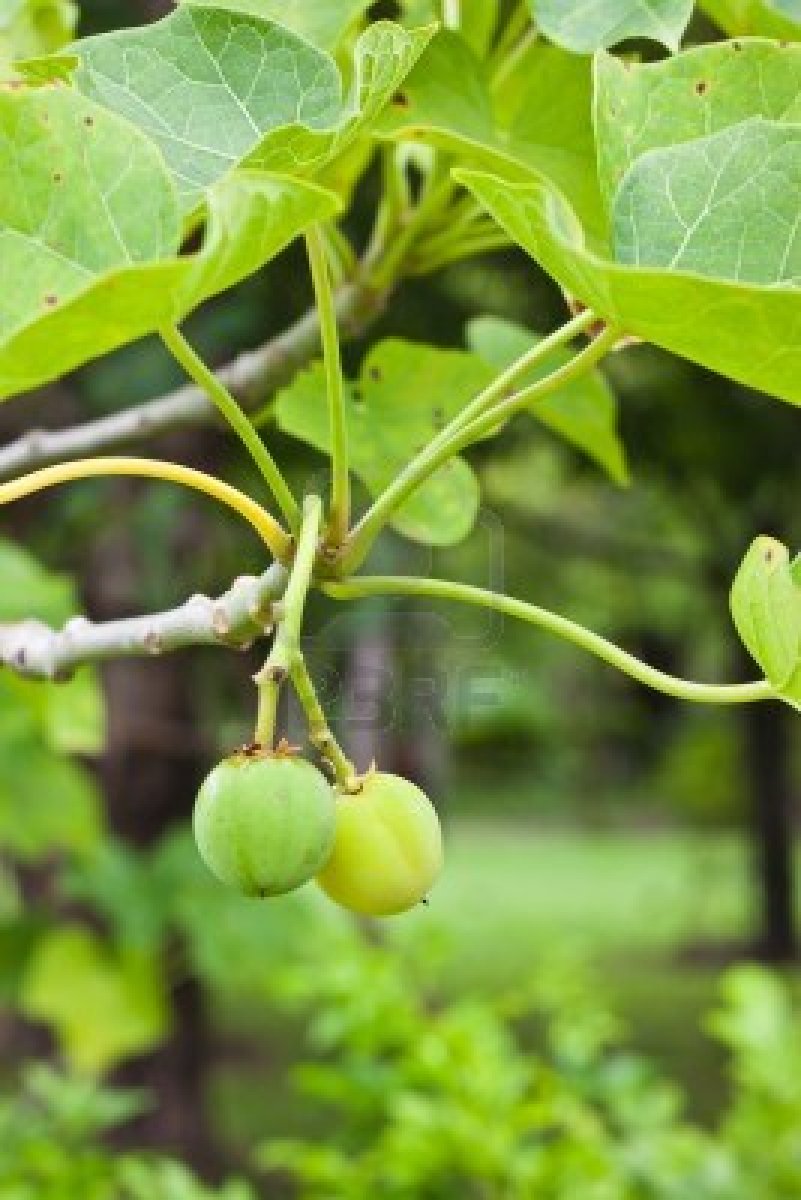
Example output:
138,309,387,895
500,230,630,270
0,456,291,560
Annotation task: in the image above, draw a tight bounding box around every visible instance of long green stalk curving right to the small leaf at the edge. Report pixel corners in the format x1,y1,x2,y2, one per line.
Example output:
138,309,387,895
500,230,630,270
324,575,776,704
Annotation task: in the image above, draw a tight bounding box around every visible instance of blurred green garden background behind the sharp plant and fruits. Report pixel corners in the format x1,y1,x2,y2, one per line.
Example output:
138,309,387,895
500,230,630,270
0,0,801,1200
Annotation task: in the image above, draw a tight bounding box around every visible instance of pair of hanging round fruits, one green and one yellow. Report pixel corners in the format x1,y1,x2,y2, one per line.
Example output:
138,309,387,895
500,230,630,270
194,748,442,917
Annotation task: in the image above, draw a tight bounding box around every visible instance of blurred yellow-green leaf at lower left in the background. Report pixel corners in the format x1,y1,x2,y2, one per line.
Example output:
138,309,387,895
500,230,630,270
20,925,169,1075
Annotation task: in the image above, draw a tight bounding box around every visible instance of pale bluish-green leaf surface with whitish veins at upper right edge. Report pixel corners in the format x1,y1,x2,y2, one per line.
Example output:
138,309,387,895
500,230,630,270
613,118,801,283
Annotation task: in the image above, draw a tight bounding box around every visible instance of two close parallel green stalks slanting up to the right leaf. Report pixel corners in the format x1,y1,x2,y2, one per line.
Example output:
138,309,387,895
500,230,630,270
338,312,620,576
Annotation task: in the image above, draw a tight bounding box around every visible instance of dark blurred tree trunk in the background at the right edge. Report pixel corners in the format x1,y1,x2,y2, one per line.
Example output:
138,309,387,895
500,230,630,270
740,703,797,962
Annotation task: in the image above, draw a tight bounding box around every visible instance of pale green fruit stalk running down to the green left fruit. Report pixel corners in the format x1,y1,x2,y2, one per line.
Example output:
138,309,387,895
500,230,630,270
254,496,323,746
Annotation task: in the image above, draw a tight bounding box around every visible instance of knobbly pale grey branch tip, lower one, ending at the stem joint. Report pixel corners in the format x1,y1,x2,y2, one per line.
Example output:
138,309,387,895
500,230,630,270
0,564,287,680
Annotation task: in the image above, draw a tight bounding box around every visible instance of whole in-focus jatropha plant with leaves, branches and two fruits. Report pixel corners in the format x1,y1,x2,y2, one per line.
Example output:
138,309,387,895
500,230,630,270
0,0,801,914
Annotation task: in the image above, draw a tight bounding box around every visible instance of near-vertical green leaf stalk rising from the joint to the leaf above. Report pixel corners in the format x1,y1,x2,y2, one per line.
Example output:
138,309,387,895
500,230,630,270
306,227,350,547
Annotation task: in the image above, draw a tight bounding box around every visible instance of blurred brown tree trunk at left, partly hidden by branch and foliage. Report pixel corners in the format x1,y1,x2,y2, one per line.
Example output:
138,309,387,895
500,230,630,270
88,501,222,1176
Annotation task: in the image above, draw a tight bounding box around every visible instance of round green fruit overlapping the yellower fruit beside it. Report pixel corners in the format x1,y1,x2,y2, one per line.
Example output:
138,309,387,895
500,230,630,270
193,751,336,896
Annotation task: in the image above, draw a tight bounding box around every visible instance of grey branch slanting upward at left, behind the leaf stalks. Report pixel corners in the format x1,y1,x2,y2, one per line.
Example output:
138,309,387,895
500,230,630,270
0,280,387,480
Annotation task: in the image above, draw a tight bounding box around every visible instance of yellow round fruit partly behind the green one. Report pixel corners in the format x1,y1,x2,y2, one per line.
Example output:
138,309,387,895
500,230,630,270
318,772,442,917
